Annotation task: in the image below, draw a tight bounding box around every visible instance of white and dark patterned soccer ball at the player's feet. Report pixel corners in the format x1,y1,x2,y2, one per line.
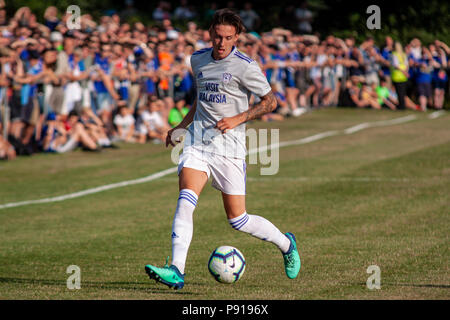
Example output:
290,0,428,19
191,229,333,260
208,246,245,283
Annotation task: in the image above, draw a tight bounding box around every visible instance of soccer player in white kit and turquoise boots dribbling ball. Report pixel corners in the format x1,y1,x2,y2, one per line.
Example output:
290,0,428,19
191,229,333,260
145,9,301,289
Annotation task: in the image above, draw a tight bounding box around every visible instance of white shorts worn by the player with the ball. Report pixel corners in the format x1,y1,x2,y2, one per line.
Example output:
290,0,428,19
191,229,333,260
178,148,247,195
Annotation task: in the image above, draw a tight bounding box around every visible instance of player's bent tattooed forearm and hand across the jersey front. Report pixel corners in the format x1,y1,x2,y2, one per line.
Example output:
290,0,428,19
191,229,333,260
216,91,277,133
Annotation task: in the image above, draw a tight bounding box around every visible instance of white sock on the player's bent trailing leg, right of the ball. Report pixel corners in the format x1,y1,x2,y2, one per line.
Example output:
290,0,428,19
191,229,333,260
228,212,291,253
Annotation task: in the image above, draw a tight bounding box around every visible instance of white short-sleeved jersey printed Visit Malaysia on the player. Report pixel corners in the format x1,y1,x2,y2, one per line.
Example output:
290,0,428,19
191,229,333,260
184,47,271,159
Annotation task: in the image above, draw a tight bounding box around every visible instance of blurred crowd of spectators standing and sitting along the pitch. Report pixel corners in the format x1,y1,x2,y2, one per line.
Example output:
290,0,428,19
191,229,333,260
0,0,450,159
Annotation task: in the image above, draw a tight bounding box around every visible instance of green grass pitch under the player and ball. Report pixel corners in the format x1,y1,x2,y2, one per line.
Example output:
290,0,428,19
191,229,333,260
0,109,450,299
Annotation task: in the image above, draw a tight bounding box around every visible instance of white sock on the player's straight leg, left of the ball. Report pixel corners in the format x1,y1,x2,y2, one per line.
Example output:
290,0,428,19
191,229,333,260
172,189,198,274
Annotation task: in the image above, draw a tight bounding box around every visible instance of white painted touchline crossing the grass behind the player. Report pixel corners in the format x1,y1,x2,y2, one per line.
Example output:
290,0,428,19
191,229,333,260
0,111,445,210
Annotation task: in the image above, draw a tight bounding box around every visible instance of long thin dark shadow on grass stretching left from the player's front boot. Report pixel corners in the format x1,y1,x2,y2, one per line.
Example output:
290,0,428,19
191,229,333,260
0,277,198,296
